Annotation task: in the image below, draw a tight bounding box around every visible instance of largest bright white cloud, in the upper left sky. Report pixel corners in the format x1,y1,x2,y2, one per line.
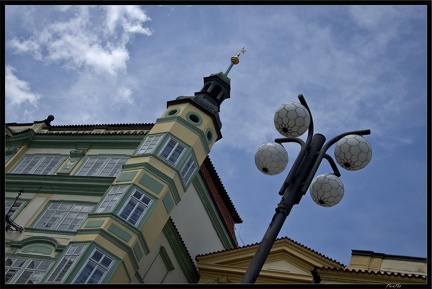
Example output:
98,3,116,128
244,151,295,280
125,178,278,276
8,6,151,77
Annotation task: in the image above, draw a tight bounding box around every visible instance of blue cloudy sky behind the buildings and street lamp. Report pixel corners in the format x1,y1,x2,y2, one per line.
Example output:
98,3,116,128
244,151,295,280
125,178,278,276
4,5,430,265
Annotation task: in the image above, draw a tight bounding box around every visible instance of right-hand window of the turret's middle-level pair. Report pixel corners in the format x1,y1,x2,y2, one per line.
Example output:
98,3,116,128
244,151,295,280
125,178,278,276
120,189,152,225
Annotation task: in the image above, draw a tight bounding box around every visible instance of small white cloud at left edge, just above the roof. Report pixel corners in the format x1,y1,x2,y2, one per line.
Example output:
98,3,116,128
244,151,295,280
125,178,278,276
5,66,40,107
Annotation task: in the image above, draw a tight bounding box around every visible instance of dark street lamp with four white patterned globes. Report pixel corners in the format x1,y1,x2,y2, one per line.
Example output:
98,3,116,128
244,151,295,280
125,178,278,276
242,94,372,283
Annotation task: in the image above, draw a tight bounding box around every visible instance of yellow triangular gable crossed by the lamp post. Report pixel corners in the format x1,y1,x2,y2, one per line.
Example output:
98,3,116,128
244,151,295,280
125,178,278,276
196,238,344,283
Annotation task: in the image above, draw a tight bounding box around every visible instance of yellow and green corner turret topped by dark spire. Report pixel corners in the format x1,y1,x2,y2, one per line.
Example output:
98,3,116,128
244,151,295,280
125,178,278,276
67,49,245,283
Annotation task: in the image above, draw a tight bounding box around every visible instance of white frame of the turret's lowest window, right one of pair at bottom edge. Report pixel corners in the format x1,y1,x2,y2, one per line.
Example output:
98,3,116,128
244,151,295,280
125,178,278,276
72,249,115,284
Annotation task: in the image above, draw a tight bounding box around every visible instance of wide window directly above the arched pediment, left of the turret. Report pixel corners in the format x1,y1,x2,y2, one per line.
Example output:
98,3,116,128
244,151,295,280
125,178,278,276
34,202,93,231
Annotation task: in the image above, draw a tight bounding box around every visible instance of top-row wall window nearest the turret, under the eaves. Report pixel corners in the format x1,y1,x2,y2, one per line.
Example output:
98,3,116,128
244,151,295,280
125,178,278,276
76,156,128,177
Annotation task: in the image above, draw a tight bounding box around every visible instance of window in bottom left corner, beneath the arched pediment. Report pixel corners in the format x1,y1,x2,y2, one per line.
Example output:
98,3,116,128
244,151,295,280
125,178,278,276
5,257,53,284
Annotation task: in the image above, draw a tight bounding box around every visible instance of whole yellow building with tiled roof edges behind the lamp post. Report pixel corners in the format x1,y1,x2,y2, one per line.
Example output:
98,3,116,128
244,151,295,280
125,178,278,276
196,237,427,286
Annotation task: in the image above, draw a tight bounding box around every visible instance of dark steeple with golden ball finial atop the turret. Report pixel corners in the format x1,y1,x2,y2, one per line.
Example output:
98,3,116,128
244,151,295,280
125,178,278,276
168,47,246,130
